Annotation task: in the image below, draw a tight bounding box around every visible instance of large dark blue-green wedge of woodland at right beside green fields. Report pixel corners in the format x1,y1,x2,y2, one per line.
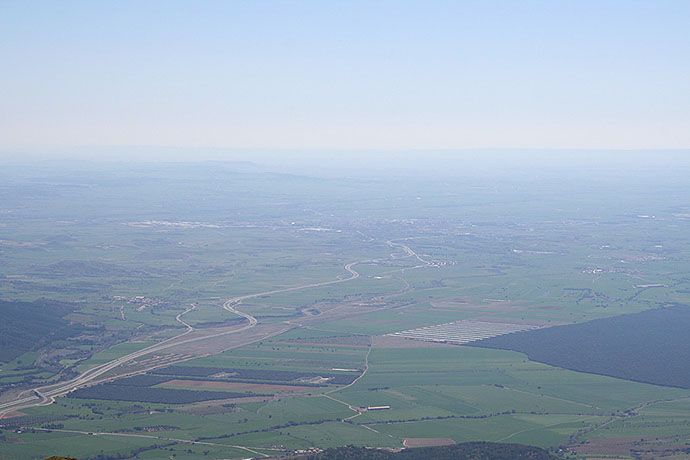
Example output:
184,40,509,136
467,306,690,389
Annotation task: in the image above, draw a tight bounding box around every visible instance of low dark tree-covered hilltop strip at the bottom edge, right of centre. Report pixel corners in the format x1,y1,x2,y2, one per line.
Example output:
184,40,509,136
293,442,556,460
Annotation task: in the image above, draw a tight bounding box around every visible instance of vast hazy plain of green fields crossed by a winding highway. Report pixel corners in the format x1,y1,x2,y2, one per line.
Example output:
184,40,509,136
0,163,690,460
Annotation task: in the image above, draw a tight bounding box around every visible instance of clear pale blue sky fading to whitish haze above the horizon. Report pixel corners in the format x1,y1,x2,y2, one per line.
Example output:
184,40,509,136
0,0,690,150
